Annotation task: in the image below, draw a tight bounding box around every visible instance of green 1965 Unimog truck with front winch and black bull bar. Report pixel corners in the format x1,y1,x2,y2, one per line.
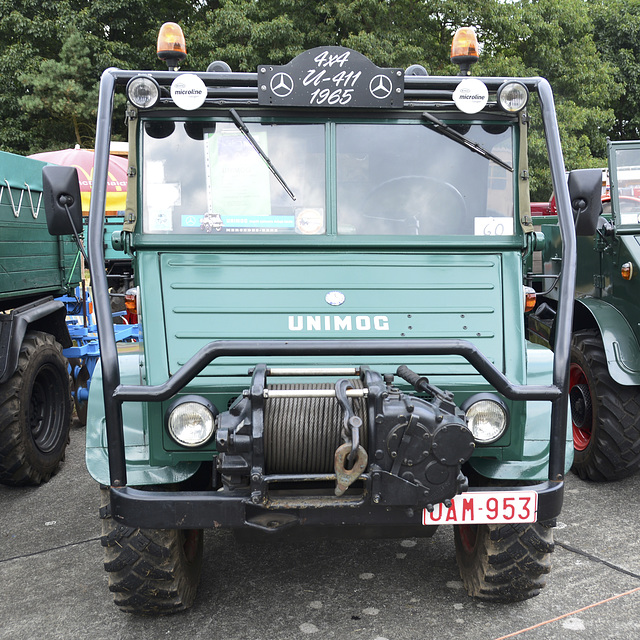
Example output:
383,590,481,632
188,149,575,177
45,23,599,613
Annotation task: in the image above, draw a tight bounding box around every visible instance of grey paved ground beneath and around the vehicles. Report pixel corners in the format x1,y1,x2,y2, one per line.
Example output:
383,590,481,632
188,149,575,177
0,418,640,640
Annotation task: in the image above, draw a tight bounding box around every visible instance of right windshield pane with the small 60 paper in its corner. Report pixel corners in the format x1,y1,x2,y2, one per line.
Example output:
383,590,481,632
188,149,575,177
337,124,513,235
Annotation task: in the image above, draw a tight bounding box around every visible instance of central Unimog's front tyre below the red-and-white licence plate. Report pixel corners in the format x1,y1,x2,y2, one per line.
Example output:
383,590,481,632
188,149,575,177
454,521,555,602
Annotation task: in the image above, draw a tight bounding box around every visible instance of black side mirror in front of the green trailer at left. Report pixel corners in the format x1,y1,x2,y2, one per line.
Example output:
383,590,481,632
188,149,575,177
42,165,82,236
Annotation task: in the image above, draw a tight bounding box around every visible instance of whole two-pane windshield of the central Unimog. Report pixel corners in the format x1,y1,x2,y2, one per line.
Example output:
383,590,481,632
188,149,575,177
142,118,514,236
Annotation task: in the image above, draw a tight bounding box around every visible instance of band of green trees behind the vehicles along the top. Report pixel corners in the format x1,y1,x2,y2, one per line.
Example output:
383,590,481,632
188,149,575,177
0,0,640,199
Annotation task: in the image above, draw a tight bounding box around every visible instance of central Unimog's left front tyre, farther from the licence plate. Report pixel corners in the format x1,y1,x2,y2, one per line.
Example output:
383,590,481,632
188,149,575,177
100,489,203,615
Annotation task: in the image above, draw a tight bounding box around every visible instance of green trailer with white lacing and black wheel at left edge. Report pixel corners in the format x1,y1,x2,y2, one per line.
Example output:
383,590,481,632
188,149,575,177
0,152,81,485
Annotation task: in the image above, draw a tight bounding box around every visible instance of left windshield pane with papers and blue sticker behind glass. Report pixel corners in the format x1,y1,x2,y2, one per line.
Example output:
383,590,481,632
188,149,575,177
143,121,325,233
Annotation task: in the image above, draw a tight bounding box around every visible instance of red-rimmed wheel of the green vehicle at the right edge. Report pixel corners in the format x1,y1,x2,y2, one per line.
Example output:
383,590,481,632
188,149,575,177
569,329,640,481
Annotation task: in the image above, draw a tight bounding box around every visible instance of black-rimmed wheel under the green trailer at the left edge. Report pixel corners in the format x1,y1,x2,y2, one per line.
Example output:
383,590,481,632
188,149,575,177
0,331,71,485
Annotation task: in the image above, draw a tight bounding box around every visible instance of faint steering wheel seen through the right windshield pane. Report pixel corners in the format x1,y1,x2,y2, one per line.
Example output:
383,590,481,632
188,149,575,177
363,176,473,235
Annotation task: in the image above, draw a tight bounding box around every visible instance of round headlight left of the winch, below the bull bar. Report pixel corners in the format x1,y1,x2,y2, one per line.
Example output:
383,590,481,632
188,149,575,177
167,396,218,447
